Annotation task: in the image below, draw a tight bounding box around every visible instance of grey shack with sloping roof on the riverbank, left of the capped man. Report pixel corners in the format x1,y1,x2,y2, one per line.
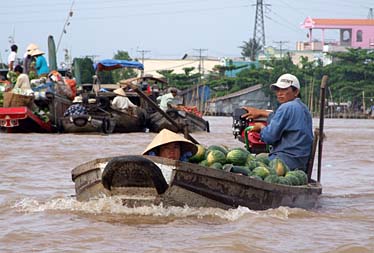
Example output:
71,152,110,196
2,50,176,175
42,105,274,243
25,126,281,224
206,84,270,115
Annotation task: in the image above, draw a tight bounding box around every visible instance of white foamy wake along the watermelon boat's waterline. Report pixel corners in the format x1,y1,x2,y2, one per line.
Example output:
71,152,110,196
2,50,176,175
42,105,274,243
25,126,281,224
12,197,259,221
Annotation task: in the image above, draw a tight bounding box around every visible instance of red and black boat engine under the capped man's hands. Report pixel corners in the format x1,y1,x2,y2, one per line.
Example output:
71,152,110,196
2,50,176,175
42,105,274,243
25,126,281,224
232,108,269,154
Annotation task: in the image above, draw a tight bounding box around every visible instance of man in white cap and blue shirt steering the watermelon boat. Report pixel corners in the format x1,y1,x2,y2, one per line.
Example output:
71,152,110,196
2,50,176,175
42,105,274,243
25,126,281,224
242,74,313,171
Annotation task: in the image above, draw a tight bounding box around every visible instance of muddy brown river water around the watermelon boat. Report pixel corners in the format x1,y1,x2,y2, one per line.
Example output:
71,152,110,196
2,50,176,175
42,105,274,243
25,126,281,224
0,117,374,253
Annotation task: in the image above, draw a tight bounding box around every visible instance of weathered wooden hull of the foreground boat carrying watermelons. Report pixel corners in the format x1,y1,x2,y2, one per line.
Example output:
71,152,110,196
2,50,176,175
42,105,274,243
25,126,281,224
72,156,322,210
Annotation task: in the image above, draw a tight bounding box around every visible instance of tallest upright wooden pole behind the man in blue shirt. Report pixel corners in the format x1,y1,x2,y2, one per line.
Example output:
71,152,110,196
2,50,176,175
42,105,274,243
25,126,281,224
317,75,328,182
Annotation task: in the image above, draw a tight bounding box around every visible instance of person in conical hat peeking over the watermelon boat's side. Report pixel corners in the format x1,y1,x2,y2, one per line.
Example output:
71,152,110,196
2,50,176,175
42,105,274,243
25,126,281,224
142,129,197,161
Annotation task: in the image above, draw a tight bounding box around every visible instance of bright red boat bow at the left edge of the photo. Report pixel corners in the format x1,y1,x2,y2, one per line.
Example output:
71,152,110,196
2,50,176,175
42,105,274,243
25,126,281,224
0,106,54,133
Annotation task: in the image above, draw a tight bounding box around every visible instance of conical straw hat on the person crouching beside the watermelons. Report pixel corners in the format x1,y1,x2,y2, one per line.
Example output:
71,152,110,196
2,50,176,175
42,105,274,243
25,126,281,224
142,129,197,155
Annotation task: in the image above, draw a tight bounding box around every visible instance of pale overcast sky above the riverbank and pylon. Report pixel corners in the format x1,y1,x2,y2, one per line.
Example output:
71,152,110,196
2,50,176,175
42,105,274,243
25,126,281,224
0,0,374,63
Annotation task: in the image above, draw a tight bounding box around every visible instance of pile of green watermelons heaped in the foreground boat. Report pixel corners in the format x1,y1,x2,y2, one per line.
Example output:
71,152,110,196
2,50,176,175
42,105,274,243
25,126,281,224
189,144,308,186
